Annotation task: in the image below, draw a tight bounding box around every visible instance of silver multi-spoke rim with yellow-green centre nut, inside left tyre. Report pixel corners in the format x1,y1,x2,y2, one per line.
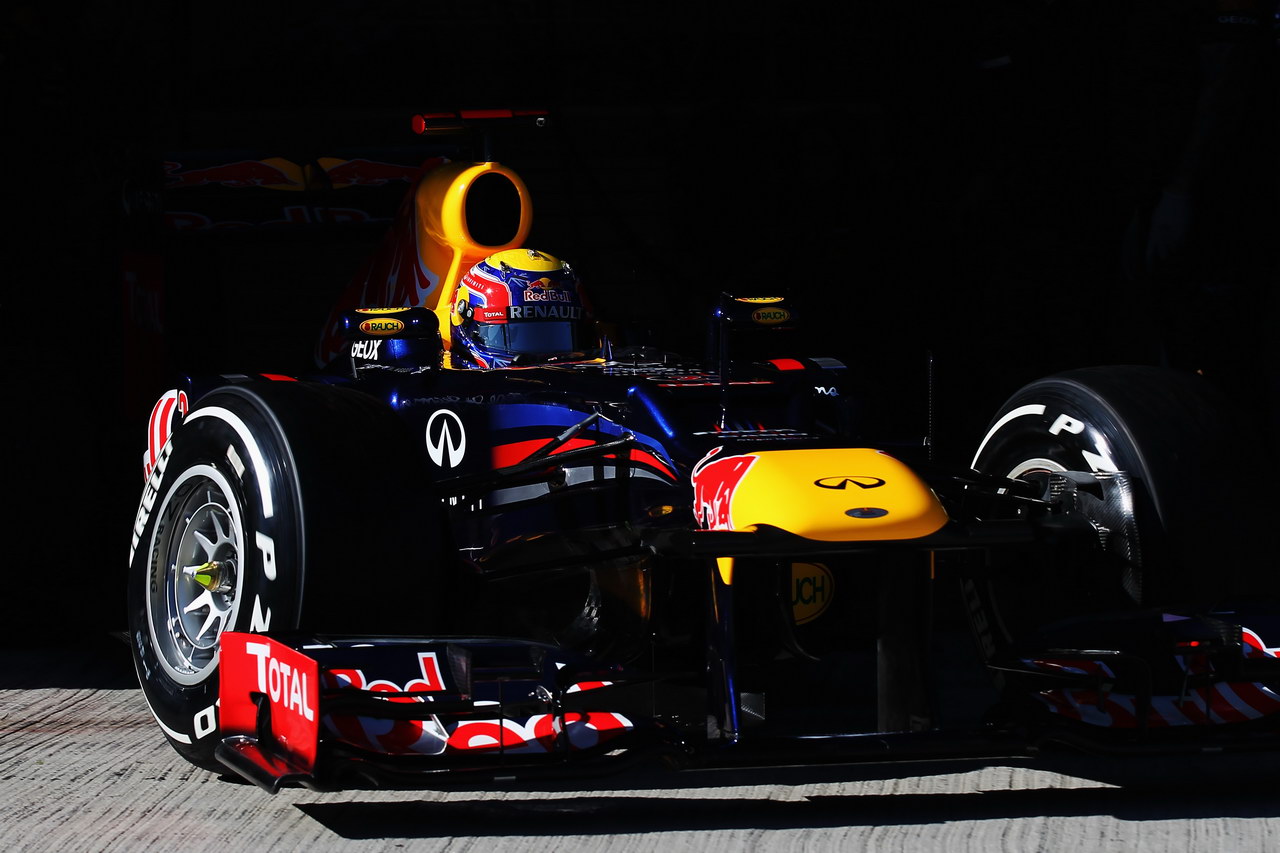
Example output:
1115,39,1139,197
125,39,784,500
147,465,244,685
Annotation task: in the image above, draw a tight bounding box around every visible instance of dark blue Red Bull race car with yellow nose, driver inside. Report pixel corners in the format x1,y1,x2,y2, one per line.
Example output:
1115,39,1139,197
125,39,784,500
128,115,1280,792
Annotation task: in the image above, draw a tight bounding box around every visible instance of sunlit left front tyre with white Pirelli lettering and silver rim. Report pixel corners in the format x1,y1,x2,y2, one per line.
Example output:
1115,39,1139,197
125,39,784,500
128,382,443,770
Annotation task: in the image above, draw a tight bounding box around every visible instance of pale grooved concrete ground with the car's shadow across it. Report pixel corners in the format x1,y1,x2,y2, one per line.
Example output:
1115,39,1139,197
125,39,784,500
0,643,1280,853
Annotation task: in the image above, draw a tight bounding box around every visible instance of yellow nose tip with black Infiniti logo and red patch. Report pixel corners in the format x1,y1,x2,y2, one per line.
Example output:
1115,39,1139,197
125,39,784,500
692,448,947,542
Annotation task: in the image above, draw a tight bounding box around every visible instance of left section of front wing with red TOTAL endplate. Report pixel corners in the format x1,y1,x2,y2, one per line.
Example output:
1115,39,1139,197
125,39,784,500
216,631,680,793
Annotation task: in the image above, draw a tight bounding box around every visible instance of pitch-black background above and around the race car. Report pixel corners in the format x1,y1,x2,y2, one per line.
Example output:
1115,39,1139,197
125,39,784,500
0,0,1280,642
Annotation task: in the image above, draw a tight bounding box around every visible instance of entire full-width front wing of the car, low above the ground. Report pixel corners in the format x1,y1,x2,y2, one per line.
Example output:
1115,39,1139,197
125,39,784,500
216,614,1280,793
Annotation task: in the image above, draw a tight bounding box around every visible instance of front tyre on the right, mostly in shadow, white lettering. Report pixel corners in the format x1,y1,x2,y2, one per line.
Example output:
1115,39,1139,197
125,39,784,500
965,365,1276,657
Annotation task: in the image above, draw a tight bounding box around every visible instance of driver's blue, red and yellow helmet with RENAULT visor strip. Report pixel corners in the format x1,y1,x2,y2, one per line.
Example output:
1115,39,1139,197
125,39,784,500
449,248,600,368
